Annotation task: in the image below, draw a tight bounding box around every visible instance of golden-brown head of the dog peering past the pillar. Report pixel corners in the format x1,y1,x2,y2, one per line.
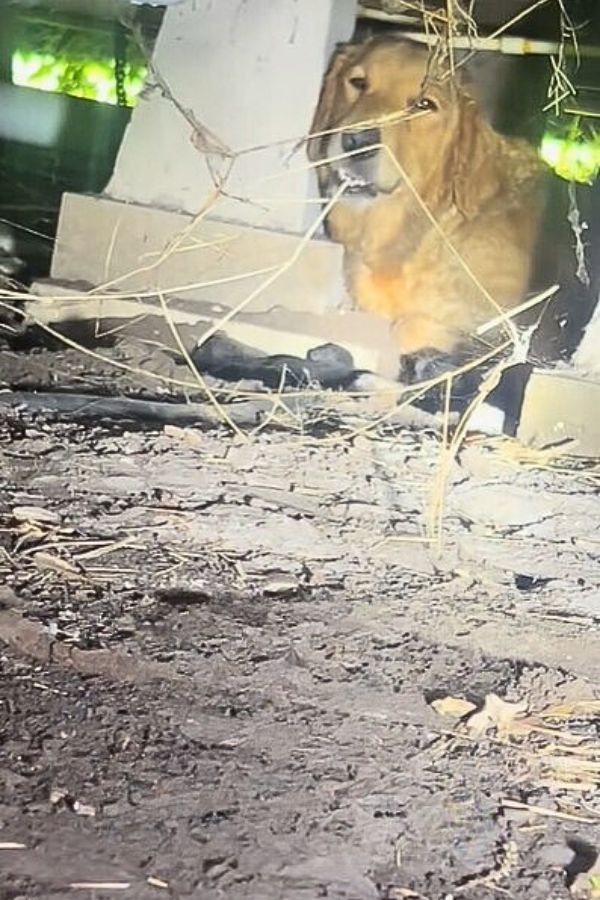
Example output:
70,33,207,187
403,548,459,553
308,39,500,213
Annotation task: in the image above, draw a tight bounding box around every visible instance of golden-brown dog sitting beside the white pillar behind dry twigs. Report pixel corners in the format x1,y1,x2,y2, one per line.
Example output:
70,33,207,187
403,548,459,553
308,38,543,370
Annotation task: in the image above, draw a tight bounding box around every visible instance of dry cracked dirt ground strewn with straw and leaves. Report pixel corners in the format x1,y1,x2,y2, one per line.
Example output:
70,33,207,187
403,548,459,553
0,346,600,900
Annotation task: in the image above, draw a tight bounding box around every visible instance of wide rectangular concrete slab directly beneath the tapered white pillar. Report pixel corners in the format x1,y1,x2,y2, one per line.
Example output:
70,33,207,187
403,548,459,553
51,194,346,312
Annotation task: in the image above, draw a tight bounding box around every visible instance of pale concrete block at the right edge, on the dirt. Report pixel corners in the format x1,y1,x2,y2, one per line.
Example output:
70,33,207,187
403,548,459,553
517,370,600,457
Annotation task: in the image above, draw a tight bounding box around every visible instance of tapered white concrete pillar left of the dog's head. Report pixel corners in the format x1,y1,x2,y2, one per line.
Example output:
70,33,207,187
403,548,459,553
107,0,356,233
